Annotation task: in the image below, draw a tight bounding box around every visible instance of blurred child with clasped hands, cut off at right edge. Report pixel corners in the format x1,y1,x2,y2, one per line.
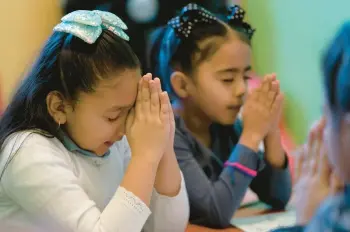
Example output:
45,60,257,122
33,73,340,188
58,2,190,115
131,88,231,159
277,21,350,232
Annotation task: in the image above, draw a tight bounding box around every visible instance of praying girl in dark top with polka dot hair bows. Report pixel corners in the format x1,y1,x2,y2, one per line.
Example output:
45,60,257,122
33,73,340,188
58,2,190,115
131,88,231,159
149,4,291,228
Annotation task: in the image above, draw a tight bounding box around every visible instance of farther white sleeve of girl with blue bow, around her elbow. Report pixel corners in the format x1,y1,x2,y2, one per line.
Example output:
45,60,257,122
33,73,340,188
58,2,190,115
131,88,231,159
144,173,190,232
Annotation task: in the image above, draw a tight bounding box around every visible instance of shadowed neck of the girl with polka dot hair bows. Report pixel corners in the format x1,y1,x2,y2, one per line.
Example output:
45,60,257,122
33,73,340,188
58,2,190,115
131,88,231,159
174,101,212,147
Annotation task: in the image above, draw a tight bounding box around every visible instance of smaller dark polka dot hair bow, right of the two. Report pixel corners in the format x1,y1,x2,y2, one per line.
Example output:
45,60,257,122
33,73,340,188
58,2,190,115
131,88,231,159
227,5,255,39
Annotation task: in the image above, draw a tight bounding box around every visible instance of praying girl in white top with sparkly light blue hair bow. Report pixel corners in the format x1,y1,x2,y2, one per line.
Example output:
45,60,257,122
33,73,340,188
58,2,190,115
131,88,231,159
0,11,189,232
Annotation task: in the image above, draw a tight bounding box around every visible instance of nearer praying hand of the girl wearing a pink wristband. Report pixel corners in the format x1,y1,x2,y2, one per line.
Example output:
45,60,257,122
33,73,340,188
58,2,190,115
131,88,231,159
240,75,283,150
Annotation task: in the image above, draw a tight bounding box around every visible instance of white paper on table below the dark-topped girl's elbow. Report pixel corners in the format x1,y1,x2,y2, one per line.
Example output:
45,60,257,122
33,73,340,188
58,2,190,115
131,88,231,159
232,210,295,232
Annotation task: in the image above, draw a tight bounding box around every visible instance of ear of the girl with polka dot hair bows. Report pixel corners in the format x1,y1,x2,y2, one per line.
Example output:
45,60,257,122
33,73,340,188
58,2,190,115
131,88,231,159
170,71,190,98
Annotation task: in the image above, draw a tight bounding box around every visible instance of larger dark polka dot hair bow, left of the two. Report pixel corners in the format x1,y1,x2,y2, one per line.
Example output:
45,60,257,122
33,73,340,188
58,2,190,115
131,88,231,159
168,3,218,39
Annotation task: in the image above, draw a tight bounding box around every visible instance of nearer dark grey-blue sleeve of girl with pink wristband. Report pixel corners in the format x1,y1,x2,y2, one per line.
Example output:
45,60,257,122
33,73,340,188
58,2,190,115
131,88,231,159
174,130,261,228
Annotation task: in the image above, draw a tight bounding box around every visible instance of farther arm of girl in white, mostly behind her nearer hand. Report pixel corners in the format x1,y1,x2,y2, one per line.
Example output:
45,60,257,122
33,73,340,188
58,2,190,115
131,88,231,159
145,78,189,232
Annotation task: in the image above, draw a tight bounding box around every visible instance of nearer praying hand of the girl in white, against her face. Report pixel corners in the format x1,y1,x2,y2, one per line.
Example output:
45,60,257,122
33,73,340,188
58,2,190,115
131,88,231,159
126,74,172,162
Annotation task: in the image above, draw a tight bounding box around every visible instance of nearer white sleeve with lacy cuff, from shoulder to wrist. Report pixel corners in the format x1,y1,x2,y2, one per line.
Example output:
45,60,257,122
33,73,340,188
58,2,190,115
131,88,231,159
0,135,151,232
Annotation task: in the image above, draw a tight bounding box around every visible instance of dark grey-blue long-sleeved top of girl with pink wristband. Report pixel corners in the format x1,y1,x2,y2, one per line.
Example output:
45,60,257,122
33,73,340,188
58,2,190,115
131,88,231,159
174,117,292,228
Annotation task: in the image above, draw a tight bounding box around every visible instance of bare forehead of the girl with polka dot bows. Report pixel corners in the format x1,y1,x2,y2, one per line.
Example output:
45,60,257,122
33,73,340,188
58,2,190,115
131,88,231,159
197,36,251,70
